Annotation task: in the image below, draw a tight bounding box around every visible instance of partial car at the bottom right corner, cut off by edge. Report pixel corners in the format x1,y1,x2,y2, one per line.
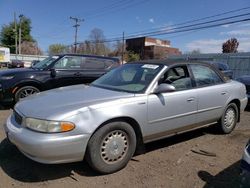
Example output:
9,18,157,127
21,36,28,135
240,140,250,187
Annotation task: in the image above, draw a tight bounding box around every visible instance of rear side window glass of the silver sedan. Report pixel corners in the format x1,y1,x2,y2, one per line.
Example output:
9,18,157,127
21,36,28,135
190,65,223,87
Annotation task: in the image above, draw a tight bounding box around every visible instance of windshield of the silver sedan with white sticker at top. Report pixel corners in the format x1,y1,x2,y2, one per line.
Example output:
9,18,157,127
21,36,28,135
91,63,163,93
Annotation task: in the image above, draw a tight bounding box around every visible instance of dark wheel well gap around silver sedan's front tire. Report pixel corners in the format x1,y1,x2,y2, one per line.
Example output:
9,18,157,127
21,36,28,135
96,117,145,154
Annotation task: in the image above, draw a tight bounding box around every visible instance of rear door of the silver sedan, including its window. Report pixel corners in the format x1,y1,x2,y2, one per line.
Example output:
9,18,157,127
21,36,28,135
190,64,229,124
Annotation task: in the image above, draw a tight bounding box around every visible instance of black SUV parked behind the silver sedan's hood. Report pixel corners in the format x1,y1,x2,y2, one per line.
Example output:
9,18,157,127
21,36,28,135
0,54,120,105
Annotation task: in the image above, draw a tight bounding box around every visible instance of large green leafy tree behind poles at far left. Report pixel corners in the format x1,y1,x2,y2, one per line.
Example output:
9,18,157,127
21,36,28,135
0,16,35,53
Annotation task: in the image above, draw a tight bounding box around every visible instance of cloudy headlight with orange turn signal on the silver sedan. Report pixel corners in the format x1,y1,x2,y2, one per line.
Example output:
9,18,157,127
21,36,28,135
25,118,75,133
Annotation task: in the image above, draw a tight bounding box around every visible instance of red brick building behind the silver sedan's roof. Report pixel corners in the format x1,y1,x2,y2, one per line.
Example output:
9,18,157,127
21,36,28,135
126,37,181,59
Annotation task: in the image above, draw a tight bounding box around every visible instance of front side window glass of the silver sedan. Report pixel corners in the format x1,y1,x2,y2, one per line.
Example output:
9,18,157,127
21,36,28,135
160,65,192,91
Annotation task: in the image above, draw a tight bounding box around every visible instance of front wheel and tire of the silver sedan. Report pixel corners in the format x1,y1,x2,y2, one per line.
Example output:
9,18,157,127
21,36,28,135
86,122,136,174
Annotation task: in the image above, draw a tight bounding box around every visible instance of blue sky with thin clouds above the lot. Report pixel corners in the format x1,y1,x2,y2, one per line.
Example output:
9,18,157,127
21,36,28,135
0,0,250,53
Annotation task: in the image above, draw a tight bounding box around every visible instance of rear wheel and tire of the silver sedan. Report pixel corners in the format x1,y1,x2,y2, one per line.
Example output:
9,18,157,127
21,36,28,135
219,103,239,134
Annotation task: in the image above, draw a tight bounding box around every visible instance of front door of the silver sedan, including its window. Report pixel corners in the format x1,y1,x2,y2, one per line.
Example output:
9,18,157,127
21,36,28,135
146,65,198,140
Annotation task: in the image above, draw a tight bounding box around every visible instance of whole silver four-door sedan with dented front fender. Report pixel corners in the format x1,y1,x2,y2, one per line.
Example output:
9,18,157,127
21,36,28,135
5,60,247,174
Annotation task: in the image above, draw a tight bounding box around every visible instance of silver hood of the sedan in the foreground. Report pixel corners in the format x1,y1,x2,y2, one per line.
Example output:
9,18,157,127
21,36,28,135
15,85,134,120
